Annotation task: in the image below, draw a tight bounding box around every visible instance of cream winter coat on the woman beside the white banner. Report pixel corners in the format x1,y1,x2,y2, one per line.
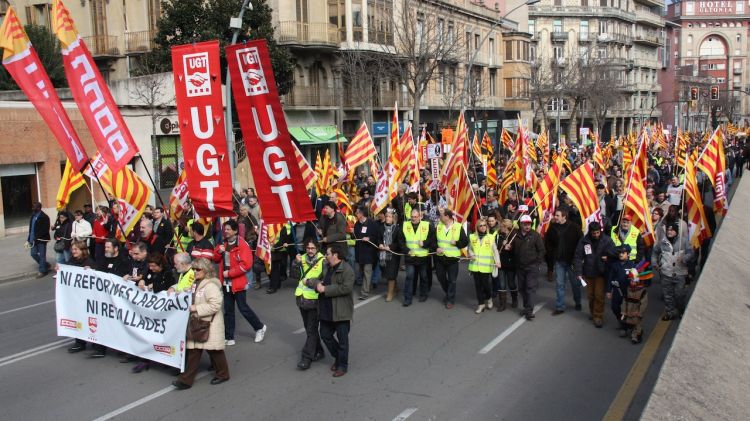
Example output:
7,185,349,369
187,278,224,351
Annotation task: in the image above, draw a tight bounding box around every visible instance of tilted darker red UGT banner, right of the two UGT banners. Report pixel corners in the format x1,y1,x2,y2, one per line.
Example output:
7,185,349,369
226,40,315,224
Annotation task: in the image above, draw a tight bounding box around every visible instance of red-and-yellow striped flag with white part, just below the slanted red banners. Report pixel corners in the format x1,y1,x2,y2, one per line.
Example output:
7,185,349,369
86,152,151,236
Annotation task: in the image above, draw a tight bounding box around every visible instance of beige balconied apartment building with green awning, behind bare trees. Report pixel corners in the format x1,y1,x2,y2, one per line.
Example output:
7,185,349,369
271,0,531,159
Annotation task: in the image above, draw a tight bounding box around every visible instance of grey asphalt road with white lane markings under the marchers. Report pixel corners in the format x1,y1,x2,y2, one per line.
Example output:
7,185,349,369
0,262,674,421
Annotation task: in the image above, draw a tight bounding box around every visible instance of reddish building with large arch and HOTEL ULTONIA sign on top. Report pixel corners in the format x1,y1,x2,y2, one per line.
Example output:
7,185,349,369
659,0,750,130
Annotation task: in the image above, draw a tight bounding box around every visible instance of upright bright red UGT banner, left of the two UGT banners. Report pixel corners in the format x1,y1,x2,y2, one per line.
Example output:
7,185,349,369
172,41,234,217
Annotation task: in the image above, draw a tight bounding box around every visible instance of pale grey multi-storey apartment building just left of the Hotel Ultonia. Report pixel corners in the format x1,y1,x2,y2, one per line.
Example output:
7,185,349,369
529,0,665,140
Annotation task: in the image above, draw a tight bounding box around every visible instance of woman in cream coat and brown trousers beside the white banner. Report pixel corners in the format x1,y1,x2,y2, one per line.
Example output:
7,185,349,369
172,258,229,390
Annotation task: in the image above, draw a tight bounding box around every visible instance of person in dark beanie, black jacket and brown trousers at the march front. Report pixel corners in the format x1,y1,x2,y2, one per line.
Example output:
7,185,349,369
573,221,615,328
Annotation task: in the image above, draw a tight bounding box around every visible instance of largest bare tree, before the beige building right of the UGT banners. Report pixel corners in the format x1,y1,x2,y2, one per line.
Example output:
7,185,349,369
386,0,462,127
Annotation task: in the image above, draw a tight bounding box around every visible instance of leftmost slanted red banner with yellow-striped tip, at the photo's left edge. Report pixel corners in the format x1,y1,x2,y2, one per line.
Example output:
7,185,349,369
0,7,89,172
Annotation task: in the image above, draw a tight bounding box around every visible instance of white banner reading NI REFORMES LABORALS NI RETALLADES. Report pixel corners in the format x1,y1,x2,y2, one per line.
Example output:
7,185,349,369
55,265,192,370
